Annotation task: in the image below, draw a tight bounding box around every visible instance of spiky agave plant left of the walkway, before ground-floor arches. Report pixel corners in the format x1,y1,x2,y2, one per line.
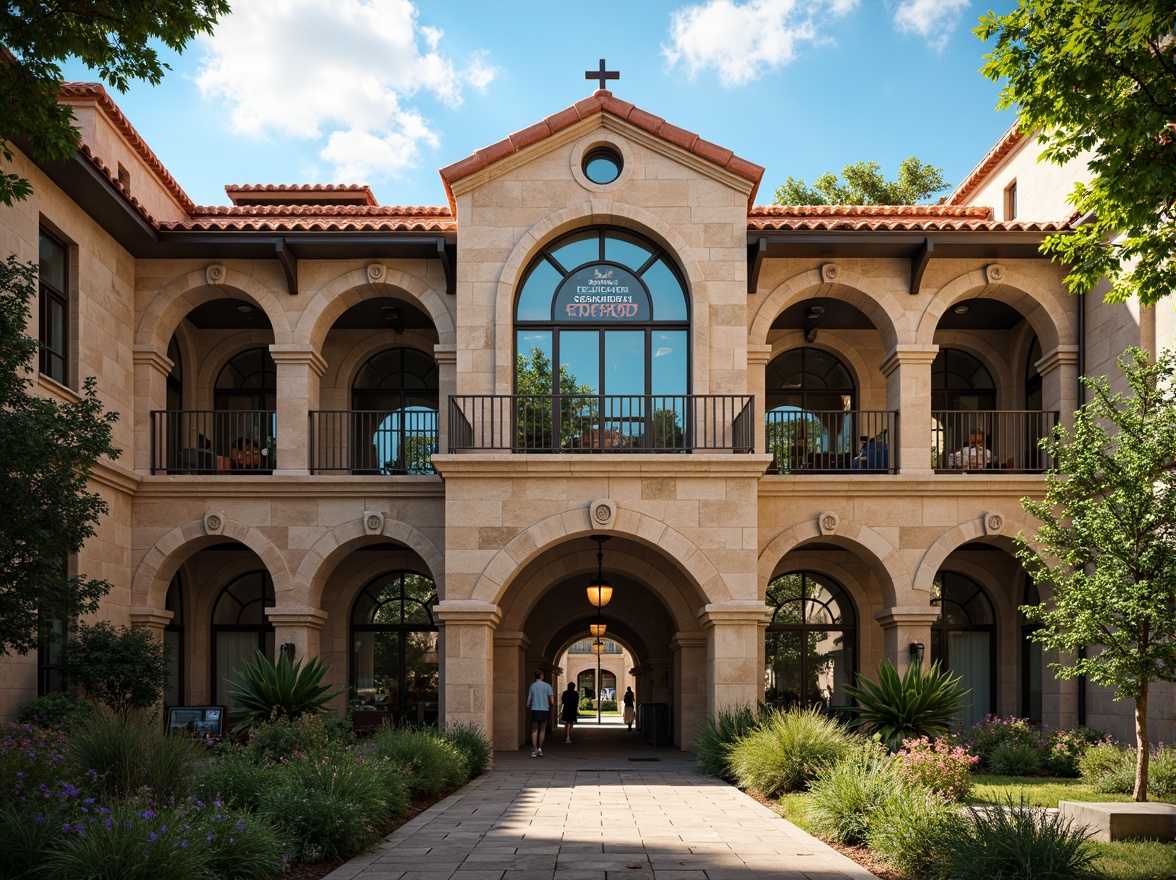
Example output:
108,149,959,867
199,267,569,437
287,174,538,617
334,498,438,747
228,651,347,733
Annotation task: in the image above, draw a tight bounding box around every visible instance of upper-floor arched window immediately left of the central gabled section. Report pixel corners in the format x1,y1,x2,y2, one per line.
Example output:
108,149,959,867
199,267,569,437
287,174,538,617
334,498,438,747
352,348,439,474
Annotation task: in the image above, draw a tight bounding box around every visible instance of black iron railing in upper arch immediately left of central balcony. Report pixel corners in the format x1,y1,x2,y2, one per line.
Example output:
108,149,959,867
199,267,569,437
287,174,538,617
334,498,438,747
310,407,437,474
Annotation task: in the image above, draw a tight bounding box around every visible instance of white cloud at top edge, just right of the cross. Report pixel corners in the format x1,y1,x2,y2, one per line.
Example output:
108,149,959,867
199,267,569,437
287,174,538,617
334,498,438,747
662,0,858,86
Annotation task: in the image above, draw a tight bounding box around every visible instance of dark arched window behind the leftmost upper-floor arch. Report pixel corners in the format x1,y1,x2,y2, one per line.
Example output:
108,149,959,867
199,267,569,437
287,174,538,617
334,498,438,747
209,348,278,471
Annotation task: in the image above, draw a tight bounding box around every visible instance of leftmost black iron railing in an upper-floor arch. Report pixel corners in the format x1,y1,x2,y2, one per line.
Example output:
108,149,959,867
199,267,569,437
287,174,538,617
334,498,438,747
151,409,278,475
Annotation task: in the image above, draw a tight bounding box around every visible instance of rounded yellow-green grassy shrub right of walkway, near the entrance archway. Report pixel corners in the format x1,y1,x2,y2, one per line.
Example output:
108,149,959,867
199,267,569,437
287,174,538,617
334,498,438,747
730,708,849,798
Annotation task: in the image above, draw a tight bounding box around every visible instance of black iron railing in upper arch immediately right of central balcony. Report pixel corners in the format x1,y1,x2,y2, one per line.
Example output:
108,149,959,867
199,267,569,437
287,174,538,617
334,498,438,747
764,409,898,474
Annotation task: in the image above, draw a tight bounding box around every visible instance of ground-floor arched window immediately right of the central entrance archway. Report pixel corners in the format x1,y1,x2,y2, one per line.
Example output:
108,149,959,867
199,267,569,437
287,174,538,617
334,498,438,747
764,572,857,709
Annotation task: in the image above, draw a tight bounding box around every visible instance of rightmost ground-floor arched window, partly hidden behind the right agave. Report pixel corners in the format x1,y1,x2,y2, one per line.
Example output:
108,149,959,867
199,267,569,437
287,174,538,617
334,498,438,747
931,572,996,727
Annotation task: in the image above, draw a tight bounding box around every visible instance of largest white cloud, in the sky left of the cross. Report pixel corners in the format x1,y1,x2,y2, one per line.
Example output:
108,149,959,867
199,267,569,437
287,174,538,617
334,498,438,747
196,0,495,182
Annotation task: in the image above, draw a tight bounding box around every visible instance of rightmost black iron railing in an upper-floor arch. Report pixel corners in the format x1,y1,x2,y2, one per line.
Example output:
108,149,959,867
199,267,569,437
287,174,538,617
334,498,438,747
931,409,1057,474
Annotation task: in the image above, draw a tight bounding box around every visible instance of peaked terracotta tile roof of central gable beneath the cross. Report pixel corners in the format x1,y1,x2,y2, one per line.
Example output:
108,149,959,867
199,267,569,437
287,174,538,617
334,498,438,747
441,89,763,211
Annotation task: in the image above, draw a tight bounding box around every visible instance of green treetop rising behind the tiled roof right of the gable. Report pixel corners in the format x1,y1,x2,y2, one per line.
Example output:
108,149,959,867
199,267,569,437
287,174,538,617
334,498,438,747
773,156,950,205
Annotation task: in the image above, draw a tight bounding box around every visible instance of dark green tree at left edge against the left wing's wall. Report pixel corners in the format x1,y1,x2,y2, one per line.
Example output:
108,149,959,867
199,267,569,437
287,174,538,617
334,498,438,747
0,256,120,654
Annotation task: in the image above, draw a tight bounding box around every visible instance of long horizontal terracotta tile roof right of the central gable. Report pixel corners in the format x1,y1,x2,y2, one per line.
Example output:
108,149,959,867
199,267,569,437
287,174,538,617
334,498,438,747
747,205,1067,232
